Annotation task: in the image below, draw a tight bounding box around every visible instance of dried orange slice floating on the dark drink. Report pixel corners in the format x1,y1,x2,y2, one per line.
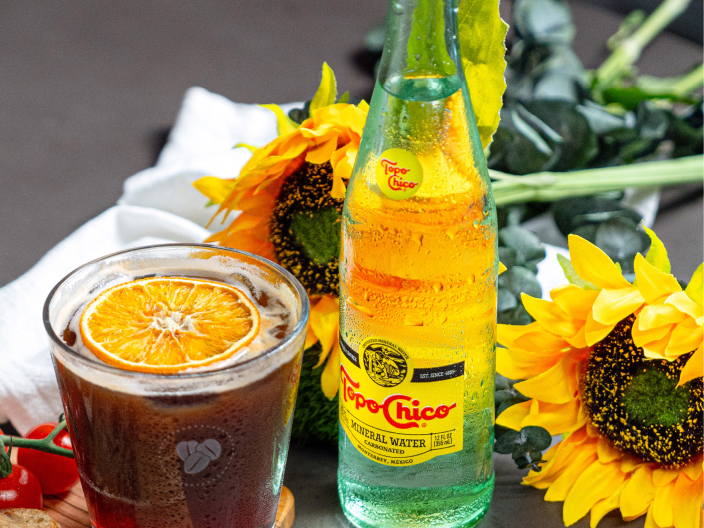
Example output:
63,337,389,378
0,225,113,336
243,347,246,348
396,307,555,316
80,277,260,373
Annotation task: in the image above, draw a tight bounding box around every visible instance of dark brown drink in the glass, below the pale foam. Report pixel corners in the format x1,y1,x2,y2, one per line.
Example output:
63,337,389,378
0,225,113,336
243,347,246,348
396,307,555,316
52,353,301,528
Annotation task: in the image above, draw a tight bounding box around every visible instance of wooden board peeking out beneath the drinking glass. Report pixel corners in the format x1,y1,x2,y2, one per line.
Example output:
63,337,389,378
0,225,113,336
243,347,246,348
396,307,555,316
44,482,294,528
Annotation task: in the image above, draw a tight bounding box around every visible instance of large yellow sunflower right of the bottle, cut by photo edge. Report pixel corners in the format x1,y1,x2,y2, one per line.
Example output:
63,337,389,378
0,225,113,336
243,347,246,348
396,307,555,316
497,231,704,528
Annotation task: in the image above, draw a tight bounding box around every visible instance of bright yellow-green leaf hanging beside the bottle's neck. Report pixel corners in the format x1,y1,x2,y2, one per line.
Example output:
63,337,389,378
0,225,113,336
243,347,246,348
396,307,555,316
457,0,508,148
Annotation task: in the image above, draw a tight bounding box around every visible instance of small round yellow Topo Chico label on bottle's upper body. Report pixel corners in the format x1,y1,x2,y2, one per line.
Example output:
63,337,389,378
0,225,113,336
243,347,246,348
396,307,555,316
376,148,423,200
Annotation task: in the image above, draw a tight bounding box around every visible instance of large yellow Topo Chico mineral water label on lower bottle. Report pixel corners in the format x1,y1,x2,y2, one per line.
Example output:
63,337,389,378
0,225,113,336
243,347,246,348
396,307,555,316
339,337,464,466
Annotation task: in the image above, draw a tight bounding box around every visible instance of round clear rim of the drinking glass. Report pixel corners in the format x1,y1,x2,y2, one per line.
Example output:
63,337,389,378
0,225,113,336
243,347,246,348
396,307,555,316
42,242,310,380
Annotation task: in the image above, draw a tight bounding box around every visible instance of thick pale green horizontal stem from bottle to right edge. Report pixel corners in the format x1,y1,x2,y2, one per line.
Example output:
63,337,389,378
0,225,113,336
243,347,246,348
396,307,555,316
489,155,704,205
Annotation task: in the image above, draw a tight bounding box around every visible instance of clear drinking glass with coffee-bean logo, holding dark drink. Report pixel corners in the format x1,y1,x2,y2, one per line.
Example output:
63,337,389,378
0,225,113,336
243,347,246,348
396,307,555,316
43,244,309,528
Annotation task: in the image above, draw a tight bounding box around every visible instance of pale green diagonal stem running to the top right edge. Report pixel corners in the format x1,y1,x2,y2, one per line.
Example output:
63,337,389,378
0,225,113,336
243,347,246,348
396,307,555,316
594,0,691,91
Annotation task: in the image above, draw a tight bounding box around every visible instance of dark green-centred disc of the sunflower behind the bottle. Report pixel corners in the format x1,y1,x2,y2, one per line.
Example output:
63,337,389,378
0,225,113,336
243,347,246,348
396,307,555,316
269,162,343,295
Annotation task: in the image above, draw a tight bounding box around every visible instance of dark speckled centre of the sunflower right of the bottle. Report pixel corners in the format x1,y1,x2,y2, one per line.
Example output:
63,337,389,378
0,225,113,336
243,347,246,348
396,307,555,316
582,315,704,467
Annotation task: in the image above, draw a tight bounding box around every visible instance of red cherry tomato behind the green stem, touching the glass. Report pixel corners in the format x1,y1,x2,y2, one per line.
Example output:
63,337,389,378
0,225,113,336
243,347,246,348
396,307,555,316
17,423,78,495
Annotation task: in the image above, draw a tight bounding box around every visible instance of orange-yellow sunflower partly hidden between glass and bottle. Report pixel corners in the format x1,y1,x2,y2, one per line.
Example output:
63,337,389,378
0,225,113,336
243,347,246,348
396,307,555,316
194,64,368,399
